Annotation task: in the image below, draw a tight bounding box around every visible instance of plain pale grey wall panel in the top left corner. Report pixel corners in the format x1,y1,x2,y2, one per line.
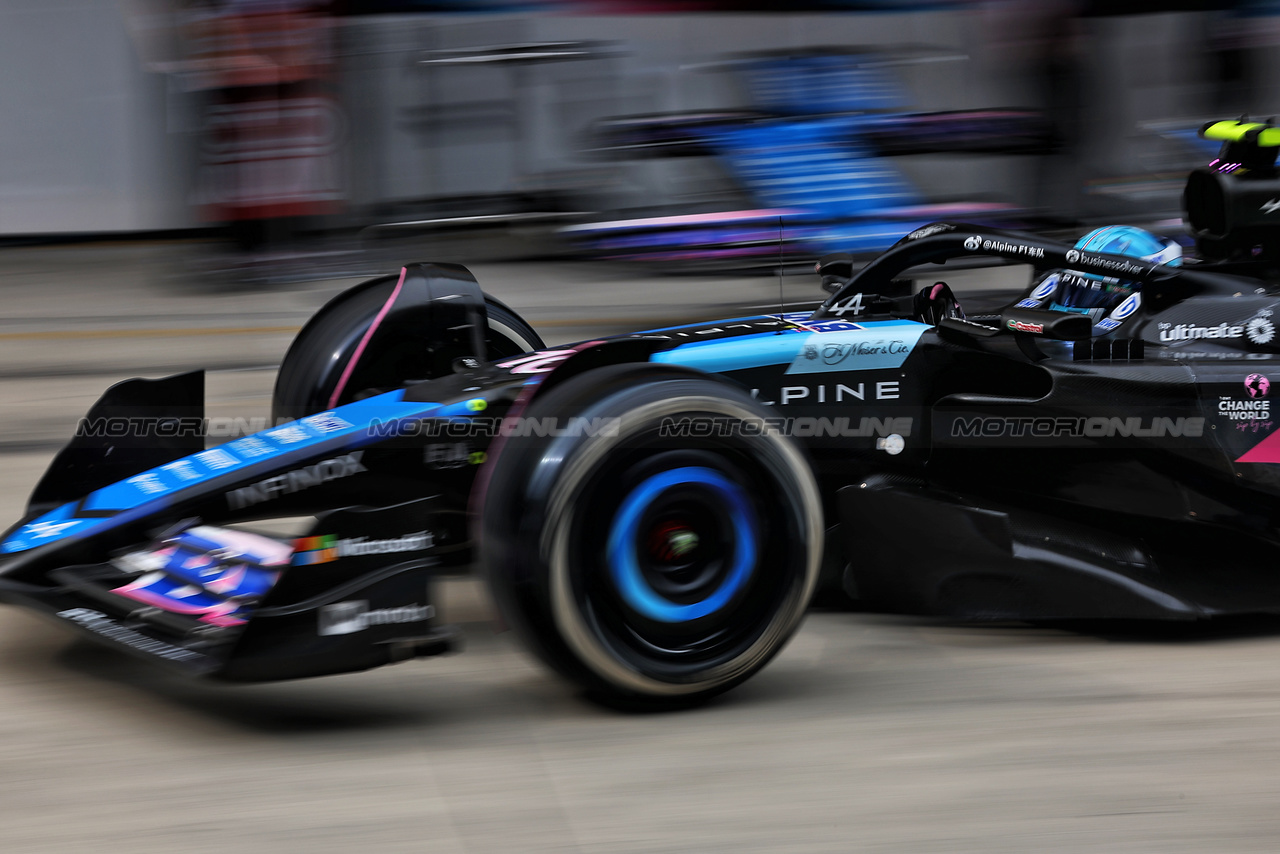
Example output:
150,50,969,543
0,0,189,234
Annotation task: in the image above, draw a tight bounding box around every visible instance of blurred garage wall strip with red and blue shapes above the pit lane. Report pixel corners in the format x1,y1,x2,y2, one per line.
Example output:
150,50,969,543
10,0,1280,284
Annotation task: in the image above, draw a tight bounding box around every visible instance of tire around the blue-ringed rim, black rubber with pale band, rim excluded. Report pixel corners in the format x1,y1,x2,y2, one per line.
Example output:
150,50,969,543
481,365,822,703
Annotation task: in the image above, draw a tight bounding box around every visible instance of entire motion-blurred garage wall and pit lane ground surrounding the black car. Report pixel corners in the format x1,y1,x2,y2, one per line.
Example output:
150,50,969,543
12,6,1280,854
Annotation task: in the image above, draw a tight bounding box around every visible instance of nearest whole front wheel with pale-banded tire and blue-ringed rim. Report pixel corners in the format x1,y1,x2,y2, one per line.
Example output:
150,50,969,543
480,364,823,709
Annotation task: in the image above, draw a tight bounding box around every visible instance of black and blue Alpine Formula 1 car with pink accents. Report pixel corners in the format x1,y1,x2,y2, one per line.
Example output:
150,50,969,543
0,123,1280,705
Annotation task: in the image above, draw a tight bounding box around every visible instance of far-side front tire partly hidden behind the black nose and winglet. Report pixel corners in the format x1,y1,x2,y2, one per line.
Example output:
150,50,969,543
271,275,545,424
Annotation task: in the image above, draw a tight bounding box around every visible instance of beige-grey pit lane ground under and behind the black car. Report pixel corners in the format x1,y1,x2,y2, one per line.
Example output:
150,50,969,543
0,246,1280,854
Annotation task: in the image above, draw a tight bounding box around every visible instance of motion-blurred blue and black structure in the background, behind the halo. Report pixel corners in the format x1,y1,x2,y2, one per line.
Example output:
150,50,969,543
564,47,1052,265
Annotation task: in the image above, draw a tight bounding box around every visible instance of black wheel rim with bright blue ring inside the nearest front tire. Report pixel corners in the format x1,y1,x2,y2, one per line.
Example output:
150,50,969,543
567,448,795,682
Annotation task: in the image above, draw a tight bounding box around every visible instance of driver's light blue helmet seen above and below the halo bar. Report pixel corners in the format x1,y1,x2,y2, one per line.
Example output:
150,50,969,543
1030,225,1183,320
